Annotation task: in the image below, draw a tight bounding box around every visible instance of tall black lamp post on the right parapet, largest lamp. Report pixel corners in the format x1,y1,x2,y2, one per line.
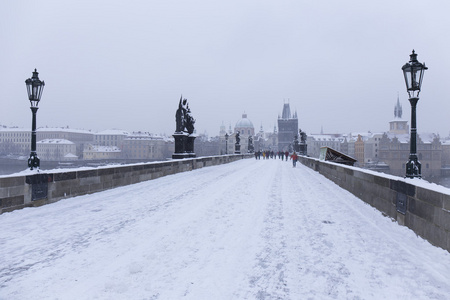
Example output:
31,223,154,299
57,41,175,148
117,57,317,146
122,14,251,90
402,50,428,178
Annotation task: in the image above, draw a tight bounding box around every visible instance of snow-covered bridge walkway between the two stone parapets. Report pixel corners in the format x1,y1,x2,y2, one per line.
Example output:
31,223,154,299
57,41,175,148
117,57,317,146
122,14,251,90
0,159,450,300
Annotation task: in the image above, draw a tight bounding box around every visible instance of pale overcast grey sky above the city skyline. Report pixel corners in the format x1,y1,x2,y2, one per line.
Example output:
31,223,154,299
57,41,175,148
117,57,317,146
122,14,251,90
0,0,450,136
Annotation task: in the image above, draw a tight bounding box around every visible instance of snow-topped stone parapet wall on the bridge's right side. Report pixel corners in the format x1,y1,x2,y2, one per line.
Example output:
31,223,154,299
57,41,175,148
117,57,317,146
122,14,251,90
299,156,450,252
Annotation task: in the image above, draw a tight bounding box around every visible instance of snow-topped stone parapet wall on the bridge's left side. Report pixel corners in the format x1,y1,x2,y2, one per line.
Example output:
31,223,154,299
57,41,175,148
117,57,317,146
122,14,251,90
0,154,253,213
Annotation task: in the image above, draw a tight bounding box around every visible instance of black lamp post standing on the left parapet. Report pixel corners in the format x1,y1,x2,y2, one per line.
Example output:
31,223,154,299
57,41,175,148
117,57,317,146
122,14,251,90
25,69,45,170
